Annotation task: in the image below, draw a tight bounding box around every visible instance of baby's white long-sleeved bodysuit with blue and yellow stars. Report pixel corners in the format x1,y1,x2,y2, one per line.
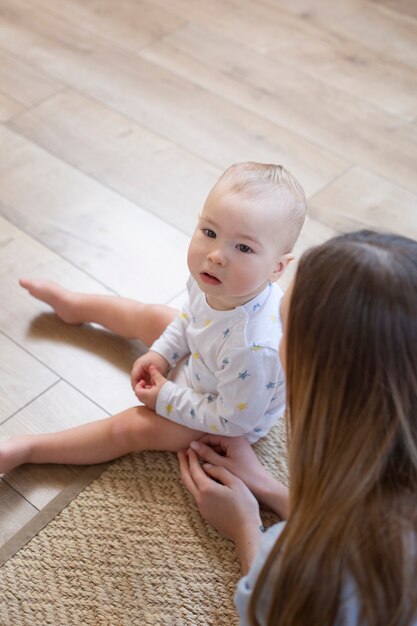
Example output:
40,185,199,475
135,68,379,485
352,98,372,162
150,277,285,443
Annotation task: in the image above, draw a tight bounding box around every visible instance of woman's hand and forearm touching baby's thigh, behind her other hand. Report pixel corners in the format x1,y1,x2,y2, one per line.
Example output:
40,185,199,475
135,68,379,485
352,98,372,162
191,435,289,519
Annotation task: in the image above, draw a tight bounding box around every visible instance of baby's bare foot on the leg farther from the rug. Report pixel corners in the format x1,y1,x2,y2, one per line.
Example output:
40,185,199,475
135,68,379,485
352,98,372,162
19,278,84,324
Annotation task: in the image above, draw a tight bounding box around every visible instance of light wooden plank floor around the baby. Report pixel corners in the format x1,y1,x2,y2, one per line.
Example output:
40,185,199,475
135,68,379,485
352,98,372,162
0,0,417,544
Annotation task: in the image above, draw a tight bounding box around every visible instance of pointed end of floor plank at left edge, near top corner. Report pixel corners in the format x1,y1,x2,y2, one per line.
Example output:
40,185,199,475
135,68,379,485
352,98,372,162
0,51,63,109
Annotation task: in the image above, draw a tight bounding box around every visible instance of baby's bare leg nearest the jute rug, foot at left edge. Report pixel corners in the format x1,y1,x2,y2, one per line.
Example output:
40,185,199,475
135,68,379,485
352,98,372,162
0,406,203,473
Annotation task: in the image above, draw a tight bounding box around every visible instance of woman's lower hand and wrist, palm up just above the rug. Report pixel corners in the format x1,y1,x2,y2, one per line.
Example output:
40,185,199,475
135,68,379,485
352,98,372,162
178,450,262,573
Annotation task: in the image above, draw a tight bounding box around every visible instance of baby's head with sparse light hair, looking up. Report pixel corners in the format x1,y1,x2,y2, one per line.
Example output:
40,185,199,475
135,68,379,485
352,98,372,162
188,163,306,309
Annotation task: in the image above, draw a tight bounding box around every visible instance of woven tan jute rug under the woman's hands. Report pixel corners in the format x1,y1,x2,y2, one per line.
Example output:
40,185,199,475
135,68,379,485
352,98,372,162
0,422,286,626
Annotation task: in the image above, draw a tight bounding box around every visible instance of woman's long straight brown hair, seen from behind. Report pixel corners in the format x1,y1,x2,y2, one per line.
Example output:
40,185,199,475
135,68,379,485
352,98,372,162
249,231,417,626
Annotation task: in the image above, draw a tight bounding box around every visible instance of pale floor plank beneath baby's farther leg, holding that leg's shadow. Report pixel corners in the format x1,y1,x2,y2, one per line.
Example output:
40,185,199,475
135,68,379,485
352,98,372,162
0,218,167,413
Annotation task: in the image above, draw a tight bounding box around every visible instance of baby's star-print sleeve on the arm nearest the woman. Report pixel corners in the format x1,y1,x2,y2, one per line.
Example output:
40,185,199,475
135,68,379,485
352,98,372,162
150,346,284,436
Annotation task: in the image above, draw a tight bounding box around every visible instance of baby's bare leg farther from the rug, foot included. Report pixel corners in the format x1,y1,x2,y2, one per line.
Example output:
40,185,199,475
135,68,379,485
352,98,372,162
20,279,177,346
